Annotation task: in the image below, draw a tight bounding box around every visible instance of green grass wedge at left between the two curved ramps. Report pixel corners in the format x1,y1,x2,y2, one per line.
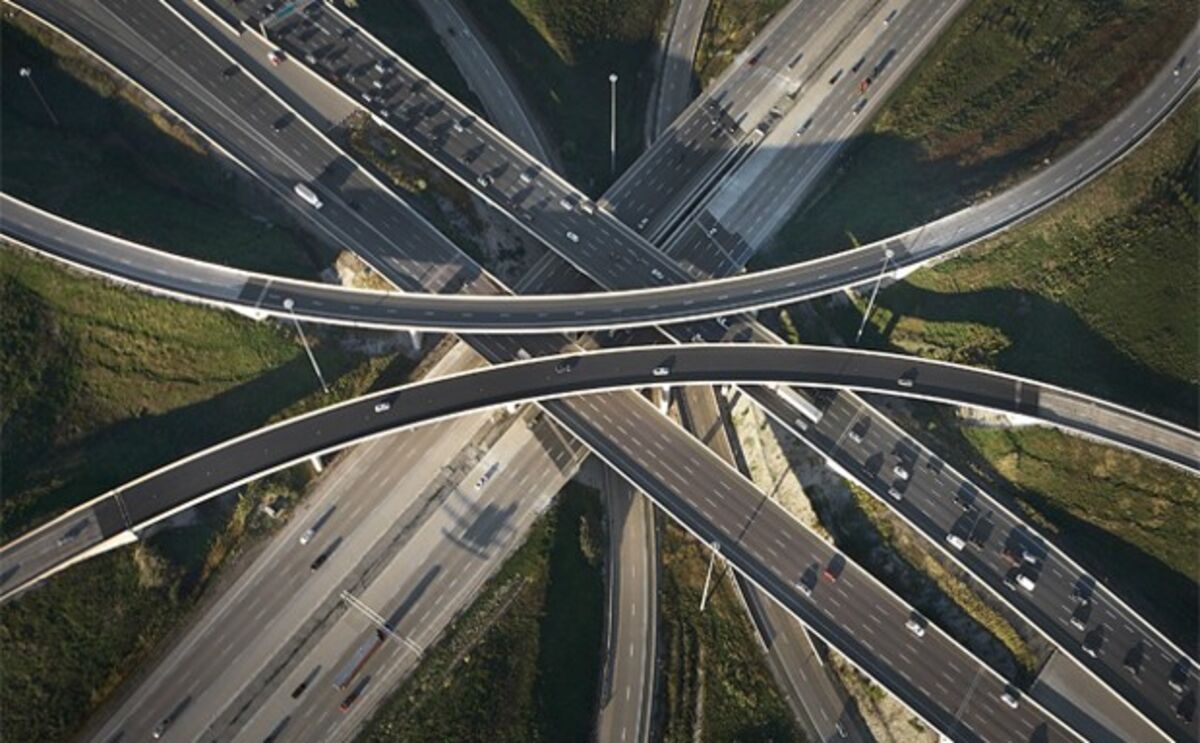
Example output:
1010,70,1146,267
0,247,408,538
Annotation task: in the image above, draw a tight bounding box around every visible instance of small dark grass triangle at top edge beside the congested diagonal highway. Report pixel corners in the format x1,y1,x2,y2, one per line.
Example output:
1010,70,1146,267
342,0,482,110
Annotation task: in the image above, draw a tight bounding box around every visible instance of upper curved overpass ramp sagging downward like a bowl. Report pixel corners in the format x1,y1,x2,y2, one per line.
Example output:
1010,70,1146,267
0,29,1200,334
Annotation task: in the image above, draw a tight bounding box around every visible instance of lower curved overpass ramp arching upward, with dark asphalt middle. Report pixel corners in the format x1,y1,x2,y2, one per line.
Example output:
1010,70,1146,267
0,343,1200,600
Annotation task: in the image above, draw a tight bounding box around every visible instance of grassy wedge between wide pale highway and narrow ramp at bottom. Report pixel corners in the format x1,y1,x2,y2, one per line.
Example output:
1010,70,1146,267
360,484,605,743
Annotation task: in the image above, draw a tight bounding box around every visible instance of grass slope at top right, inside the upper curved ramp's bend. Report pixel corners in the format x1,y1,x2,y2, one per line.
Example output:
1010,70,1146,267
755,0,1196,265
